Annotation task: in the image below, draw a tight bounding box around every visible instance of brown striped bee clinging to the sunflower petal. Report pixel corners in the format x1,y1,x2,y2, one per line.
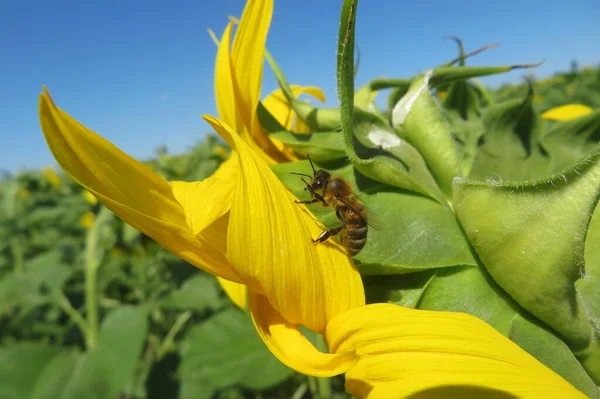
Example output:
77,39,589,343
290,155,369,256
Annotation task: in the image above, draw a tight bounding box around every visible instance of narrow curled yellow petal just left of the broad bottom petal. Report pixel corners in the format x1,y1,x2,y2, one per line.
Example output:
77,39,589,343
249,293,357,377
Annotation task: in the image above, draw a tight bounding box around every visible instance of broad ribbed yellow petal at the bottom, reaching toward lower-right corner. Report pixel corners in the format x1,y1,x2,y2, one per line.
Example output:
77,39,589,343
326,304,585,398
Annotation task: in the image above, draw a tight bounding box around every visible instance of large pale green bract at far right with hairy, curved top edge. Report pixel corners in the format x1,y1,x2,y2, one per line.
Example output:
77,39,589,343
454,147,600,368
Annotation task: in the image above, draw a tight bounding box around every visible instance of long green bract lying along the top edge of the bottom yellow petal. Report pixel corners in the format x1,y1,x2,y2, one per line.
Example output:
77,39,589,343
365,266,600,398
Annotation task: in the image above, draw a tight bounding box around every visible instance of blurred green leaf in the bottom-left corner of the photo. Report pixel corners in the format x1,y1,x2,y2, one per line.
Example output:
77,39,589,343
0,342,61,399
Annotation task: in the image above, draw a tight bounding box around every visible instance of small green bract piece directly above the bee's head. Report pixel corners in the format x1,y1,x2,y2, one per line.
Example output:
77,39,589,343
271,132,346,162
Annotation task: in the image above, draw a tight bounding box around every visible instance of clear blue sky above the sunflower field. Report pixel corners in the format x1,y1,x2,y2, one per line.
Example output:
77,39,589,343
0,0,600,171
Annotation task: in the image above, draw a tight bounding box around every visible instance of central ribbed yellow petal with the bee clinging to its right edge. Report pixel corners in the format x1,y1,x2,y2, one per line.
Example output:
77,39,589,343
204,116,364,332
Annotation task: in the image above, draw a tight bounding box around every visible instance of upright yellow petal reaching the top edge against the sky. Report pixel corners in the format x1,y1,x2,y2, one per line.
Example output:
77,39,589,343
231,0,273,136
